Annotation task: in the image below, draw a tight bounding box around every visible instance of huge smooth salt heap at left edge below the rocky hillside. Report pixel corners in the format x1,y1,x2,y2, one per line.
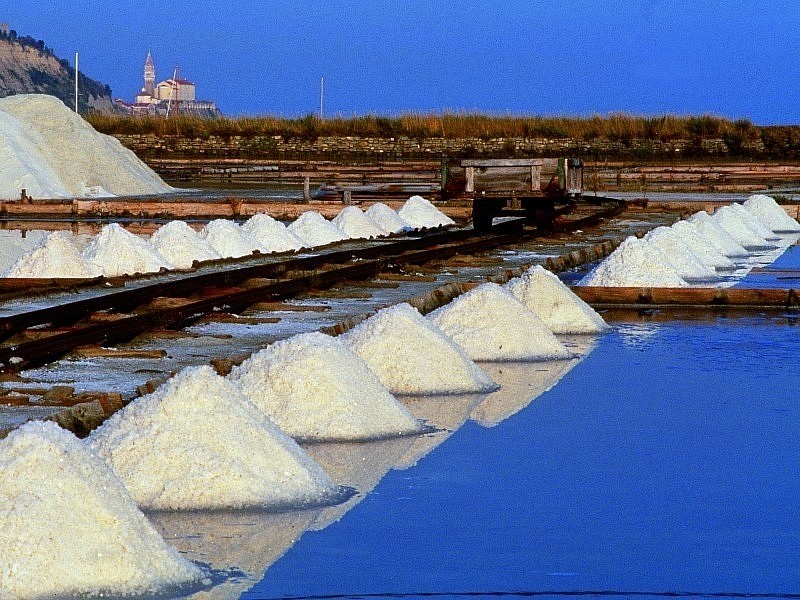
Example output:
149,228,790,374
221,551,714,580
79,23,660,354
0,94,174,198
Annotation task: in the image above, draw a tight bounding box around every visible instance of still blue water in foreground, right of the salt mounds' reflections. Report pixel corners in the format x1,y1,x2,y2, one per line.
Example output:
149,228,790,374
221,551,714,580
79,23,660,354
243,316,800,598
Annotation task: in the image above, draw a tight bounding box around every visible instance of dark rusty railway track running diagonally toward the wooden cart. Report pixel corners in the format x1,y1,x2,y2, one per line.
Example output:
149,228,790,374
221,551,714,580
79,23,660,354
0,202,624,373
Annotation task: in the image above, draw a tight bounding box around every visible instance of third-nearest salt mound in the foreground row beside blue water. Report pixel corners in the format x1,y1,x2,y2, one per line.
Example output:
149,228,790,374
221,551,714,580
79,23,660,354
229,332,421,440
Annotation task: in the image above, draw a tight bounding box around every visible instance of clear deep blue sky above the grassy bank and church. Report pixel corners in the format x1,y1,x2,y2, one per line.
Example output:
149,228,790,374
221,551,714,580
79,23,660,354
6,0,800,125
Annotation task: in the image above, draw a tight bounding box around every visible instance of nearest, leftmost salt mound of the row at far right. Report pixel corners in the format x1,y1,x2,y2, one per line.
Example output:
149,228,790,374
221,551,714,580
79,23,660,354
579,236,689,287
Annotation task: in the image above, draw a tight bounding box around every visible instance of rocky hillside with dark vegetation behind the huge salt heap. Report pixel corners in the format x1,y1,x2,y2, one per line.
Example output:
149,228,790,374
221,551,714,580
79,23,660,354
0,30,113,111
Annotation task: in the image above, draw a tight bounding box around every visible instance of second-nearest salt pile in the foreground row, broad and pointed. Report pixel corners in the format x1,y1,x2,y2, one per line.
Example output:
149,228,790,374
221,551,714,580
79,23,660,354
88,366,338,510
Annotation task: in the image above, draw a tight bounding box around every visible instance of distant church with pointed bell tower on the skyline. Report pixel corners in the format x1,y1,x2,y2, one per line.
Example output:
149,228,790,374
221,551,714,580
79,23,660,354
117,52,221,117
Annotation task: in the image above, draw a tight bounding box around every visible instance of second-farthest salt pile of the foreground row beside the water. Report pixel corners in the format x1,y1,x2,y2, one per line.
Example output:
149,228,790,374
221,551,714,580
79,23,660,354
427,283,572,361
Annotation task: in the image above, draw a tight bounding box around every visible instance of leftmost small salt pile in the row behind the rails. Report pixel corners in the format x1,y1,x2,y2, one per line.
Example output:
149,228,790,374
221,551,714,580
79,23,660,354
3,231,103,278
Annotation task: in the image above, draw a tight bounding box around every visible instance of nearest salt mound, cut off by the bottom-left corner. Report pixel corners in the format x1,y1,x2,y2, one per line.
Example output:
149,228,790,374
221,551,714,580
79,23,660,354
0,421,203,598
